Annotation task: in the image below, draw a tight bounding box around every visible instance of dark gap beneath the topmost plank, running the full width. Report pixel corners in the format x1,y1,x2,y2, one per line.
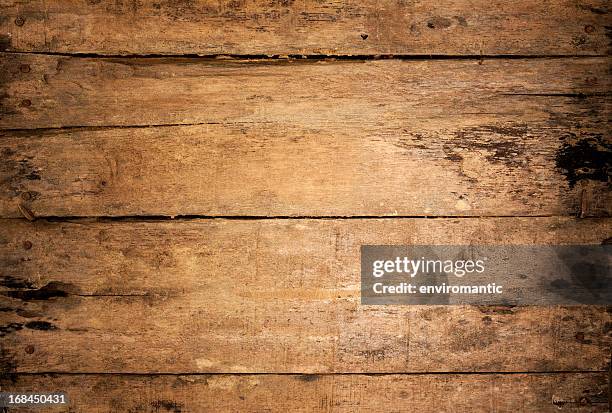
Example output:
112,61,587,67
0,50,610,61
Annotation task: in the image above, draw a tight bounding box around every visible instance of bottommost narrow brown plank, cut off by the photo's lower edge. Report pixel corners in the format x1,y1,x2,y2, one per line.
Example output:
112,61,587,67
2,373,608,413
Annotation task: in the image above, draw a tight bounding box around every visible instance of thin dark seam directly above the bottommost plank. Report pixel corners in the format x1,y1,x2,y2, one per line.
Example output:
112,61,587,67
4,370,608,376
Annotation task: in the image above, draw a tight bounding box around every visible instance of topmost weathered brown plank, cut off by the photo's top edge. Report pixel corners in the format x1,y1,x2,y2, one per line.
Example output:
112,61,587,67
0,0,610,55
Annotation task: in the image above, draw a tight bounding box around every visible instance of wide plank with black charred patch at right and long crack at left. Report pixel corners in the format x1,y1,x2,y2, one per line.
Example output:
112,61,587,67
0,55,612,217
